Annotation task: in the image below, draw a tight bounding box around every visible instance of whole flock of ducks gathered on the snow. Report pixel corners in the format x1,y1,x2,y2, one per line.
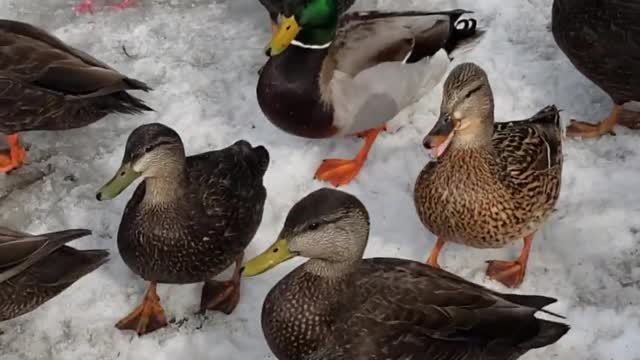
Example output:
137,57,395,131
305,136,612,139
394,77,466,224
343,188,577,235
0,0,640,360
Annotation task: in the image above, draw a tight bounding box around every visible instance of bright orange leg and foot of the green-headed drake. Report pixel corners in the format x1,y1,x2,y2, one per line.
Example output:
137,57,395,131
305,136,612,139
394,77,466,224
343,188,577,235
315,126,385,187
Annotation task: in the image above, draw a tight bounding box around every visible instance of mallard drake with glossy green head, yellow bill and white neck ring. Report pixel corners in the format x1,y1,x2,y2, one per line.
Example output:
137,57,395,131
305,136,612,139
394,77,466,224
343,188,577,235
257,0,476,186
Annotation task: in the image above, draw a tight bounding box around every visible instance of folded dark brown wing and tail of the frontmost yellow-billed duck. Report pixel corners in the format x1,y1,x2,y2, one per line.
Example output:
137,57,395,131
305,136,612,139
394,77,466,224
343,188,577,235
312,258,569,360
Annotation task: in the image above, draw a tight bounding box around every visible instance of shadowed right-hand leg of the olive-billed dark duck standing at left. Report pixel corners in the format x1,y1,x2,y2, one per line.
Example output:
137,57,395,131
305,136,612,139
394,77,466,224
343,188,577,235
200,253,244,315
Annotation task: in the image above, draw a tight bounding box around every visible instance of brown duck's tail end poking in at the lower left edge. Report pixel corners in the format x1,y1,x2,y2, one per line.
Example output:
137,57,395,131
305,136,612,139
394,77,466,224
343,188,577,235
0,227,109,321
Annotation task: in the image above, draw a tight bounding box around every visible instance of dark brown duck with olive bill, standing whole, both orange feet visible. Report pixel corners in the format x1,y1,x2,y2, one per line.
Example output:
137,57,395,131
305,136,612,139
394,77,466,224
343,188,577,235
97,124,269,335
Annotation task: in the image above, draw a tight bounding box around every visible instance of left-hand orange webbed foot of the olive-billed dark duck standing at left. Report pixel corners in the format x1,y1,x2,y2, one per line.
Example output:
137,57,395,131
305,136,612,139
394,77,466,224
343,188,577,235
116,281,167,335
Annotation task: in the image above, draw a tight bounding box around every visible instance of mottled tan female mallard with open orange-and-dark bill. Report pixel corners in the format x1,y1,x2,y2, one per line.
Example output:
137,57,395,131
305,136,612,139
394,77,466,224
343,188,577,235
415,63,562,287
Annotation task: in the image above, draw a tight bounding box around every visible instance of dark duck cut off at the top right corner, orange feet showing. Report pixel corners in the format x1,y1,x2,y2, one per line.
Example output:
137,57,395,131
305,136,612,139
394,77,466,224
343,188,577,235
551,0,640,137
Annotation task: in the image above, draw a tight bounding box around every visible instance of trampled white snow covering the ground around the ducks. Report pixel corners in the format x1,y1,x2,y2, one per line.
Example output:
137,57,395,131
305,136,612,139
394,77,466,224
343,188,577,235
0,0,640,360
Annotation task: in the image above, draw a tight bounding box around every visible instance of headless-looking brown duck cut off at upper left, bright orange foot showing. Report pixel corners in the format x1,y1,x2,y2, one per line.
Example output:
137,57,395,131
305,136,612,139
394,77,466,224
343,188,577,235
0,20,152,172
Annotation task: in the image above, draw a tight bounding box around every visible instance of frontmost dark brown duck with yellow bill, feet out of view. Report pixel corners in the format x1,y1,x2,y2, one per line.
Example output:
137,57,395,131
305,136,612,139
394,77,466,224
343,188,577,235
242,189,569,360
